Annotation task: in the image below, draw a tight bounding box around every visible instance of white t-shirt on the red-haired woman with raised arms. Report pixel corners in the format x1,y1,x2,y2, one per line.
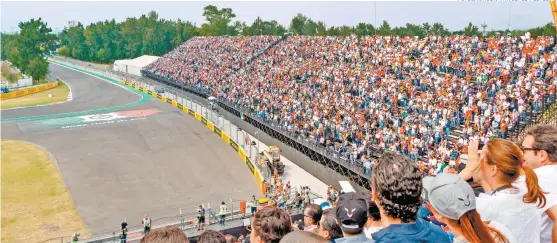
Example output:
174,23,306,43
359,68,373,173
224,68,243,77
476,188,541,243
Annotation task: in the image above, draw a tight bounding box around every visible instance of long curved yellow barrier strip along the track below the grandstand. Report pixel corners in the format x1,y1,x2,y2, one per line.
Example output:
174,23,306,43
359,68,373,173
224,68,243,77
121,80,264,192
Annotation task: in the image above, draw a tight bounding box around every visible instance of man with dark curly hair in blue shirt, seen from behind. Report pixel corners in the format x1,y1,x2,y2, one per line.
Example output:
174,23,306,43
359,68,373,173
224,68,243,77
371,152,451,243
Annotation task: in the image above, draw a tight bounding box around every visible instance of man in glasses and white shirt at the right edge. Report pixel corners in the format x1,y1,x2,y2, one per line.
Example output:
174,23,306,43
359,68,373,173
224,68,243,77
513,125,557,242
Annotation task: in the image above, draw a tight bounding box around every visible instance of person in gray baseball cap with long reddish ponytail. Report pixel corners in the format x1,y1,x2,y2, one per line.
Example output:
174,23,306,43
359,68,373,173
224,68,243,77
423,173,517,243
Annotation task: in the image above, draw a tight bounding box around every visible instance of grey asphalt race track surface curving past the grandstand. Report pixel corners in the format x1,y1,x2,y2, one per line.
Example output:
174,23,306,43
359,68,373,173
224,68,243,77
1,64,260,235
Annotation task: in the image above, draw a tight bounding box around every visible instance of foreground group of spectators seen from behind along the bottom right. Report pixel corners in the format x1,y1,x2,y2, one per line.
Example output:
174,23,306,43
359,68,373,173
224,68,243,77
136,125,557,243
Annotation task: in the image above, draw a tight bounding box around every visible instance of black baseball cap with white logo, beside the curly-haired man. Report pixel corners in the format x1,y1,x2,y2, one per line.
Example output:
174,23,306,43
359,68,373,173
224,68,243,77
336,192,368,229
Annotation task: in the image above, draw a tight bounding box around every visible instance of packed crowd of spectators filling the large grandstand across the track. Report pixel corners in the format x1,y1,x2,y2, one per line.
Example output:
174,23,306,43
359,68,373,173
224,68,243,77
142,35,557,175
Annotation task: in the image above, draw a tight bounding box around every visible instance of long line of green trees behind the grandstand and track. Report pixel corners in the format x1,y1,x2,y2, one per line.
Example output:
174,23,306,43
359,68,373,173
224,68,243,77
2,5,556,70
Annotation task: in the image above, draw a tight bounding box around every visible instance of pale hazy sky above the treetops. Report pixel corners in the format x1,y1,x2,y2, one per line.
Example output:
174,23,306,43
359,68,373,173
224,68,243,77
0,1,552,32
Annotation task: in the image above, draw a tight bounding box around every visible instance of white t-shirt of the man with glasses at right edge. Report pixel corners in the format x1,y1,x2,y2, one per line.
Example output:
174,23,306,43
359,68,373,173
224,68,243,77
513,165,557,242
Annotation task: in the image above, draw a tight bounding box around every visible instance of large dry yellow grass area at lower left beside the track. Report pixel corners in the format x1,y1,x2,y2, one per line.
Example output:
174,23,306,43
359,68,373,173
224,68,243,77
1,141,90,243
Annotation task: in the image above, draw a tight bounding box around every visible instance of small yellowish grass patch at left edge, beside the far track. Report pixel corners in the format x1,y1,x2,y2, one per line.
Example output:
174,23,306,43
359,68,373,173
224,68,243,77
0,82,70,110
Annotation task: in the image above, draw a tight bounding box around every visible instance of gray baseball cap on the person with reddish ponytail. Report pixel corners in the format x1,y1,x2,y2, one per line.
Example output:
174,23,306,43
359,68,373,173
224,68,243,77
423,173,476,220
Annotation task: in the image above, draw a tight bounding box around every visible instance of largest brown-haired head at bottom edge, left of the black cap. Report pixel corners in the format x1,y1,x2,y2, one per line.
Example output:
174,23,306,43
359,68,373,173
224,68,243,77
249,206,292,243
